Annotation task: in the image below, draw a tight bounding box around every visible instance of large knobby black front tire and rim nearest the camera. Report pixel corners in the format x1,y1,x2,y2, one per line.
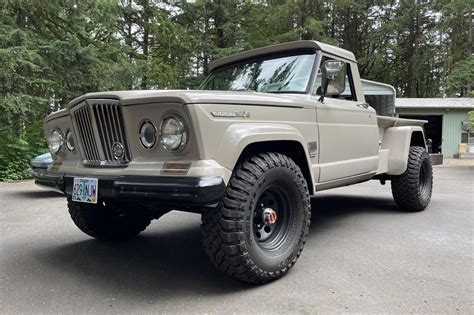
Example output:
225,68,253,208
201,153,311,283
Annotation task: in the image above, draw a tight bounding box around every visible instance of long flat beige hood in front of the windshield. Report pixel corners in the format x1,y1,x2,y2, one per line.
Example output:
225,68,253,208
68,90,310,108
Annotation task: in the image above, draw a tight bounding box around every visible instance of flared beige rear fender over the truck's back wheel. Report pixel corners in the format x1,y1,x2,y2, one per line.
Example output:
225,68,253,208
382,126,426,175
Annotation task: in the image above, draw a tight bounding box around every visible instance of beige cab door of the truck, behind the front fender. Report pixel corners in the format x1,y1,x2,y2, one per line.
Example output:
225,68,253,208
315,63,379,183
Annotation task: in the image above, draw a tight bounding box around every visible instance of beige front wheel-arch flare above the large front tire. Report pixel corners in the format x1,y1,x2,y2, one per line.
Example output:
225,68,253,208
215,123,310,170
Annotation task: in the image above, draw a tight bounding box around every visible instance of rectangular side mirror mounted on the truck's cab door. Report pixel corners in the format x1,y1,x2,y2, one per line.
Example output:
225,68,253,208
319,60,346,102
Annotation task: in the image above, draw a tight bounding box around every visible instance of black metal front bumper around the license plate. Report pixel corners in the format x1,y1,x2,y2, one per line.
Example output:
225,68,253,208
35,173,225,207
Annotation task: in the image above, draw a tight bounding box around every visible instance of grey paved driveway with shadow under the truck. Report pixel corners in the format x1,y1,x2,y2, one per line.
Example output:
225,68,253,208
0,165,474,314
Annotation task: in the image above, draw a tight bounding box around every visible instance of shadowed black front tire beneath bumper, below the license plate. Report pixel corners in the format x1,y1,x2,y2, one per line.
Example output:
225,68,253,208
68,198,151,241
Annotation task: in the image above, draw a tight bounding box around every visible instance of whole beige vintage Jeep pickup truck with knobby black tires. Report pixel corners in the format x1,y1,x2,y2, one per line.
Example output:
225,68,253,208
41,41,433,283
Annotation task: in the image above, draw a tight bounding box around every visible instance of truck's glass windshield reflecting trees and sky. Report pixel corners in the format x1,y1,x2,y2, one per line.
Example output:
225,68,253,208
200,52,316,93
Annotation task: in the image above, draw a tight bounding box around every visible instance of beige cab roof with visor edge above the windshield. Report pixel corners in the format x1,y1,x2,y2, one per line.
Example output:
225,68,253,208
209,40,356,71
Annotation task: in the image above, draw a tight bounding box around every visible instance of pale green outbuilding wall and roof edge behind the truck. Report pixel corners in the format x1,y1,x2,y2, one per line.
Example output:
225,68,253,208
396,108,470,157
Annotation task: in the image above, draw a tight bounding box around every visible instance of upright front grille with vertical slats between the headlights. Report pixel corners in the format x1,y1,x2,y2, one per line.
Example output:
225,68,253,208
71,100,129,166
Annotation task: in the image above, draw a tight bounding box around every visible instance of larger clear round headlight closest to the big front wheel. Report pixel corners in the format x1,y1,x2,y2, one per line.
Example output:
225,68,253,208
160,116,187,151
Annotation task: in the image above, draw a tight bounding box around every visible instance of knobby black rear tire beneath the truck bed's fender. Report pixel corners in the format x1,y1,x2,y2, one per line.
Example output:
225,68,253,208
391,147,433,212
